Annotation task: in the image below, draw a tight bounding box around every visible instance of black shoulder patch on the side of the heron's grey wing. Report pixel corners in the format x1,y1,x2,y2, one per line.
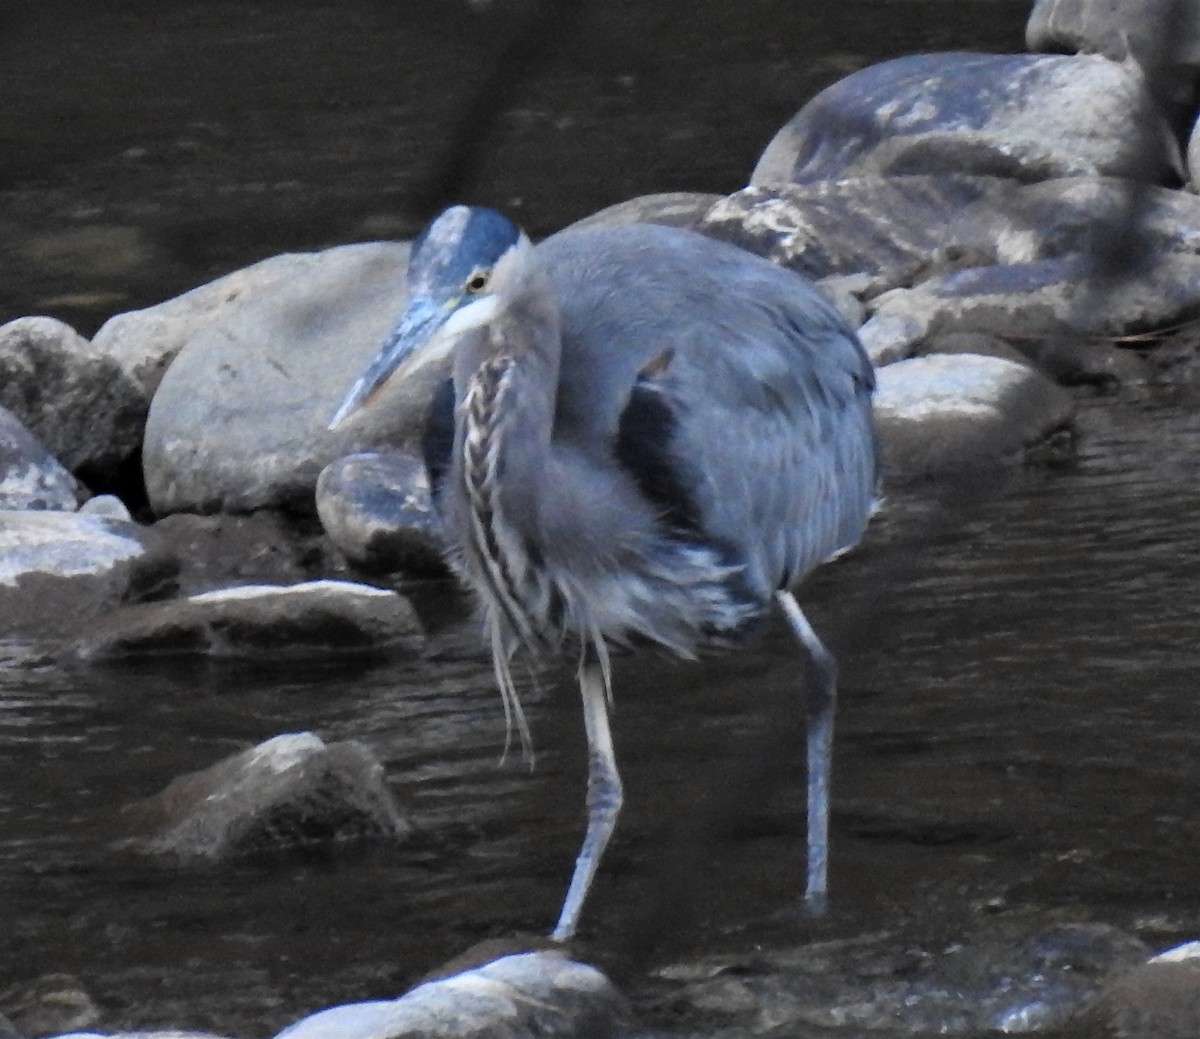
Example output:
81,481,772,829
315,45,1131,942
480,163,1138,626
614,369,700,533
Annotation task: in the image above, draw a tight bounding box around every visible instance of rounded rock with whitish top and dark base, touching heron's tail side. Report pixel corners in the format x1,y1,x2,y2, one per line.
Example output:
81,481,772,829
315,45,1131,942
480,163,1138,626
875,354,1074,478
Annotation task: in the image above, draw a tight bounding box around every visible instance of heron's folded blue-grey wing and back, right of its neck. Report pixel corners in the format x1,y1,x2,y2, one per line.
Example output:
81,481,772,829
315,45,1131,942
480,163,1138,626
539,226,876,597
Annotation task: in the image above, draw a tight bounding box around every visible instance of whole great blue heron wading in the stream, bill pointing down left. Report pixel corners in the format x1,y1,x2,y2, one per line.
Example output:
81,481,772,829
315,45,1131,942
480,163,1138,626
331,206,876,939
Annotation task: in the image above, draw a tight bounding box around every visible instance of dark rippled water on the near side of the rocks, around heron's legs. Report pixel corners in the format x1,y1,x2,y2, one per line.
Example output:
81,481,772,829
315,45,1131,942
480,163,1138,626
0,403,1200,1034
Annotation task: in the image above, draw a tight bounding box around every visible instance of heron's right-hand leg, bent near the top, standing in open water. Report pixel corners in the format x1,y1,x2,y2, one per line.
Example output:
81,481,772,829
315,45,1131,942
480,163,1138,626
778,591,838,913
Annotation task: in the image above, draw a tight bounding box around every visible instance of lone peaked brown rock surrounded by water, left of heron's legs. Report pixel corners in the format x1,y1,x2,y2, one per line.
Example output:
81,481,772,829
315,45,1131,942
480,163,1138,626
118,732,412,861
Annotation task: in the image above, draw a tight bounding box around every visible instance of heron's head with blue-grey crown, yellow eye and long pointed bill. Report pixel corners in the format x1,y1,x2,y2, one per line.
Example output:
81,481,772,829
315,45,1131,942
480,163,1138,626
329,205,530,430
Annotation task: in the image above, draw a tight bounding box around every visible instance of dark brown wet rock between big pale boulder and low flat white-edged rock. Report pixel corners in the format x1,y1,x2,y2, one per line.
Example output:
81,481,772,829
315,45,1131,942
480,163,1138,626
151,510,344,595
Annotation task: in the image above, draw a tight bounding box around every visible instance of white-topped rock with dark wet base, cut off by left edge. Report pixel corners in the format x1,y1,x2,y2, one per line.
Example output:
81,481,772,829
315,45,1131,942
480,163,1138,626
0,511,176,637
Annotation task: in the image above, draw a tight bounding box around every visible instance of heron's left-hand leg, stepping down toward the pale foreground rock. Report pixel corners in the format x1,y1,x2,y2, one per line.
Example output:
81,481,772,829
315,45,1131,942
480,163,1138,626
551,654,624,942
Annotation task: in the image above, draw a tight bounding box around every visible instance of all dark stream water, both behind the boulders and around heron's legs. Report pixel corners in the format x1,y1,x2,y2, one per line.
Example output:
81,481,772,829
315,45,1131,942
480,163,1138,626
0,0,1200,1037
